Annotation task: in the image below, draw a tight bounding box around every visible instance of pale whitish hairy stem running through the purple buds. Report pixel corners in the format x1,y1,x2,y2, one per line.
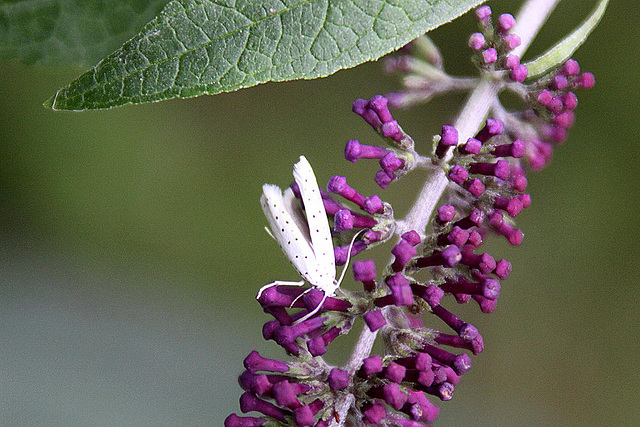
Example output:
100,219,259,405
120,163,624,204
330,0,560,427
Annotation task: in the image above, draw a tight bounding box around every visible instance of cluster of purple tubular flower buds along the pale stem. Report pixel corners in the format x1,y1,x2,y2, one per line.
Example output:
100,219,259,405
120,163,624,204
225,6,594,427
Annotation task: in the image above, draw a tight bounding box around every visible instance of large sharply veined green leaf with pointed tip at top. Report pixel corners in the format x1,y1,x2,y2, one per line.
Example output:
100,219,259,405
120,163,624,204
45,0,482,110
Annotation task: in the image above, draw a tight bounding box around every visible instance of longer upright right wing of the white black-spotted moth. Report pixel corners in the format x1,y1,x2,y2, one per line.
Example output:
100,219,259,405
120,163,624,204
293,156,336,294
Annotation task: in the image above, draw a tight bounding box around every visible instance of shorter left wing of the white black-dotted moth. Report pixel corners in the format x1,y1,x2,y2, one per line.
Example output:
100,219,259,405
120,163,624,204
260,184,317,283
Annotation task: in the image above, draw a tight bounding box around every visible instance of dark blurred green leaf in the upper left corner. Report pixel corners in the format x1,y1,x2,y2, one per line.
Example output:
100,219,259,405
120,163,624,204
0,0,168,66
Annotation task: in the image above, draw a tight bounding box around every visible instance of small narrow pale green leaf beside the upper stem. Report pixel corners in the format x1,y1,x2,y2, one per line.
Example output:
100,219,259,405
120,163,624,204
525,0,609,78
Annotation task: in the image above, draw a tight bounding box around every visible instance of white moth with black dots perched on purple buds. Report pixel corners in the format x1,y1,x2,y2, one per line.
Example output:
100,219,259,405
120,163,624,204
257,156,346,322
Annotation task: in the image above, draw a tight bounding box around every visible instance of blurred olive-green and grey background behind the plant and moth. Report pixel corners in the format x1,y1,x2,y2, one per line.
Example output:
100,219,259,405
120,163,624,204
0,0,640,426
